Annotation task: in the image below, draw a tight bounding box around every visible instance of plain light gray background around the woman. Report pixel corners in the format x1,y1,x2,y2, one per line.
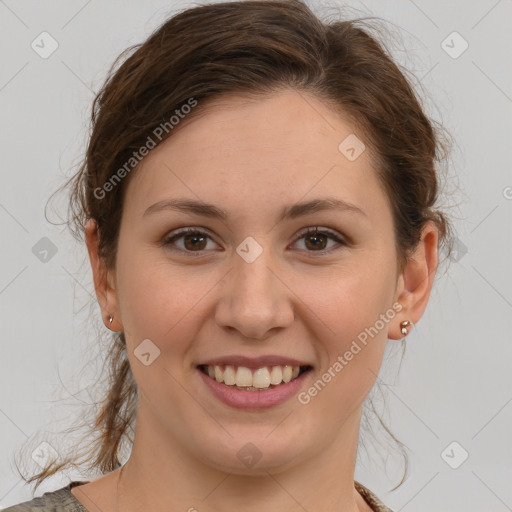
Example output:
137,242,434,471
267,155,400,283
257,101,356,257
0,0,512,512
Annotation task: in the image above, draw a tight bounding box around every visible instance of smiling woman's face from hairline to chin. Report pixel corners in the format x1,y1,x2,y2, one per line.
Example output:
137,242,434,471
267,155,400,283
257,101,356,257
98,91,426,473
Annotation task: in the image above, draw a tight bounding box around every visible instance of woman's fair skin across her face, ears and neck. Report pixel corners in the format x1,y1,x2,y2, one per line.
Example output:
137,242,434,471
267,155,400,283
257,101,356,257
72,90,438,512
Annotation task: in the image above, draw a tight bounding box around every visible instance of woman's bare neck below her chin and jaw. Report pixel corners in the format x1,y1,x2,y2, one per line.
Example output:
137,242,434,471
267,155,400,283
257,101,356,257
116,402,370,512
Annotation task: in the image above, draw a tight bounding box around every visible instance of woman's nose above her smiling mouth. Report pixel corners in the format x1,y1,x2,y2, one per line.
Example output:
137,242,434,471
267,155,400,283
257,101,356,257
215,242,294,340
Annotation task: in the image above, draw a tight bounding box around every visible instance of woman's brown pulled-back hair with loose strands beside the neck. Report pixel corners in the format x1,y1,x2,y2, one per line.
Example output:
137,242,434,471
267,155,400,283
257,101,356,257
16,0,449,489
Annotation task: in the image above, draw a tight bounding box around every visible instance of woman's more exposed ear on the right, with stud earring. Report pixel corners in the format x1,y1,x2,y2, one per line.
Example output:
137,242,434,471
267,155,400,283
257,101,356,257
388,221,439,340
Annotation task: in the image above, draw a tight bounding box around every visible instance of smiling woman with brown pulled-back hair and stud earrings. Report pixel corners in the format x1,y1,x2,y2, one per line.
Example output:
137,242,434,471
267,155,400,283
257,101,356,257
6,0,448,512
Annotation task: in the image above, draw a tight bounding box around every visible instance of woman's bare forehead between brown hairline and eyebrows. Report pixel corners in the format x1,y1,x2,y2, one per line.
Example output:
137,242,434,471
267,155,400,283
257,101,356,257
122,91,386,224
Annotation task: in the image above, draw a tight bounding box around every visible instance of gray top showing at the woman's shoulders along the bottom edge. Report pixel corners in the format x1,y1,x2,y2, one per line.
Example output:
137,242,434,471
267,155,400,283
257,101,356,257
1,481,393,512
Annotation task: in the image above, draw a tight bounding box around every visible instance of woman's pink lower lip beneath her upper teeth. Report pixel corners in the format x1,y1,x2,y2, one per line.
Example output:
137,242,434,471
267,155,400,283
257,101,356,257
197,369,311,409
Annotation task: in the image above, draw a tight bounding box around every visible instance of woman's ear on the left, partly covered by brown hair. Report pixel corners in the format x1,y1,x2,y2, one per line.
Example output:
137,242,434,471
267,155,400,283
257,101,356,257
85,219,123,332
